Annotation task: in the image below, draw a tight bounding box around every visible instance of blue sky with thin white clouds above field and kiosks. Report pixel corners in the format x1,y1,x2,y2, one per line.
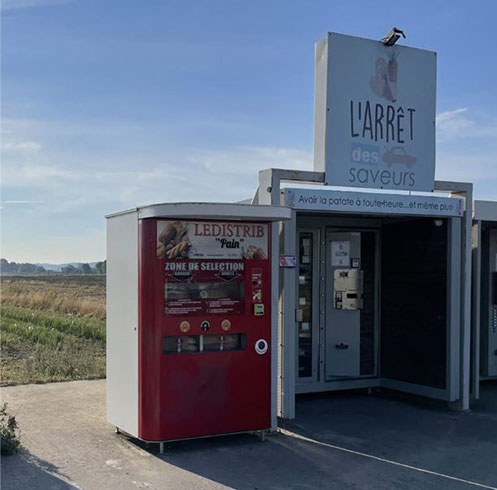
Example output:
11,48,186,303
1,0,497,262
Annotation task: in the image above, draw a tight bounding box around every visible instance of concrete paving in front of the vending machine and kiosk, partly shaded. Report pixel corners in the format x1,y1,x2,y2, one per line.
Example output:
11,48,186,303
1,381,497,490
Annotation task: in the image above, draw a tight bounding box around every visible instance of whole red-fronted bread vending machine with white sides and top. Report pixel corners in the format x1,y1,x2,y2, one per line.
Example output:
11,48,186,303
107,204,288,448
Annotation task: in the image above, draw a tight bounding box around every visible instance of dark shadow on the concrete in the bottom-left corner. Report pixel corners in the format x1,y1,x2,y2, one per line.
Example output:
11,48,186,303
1,449,79,490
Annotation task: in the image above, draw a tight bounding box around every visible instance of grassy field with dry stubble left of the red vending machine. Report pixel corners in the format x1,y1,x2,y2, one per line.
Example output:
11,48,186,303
0,276,105,386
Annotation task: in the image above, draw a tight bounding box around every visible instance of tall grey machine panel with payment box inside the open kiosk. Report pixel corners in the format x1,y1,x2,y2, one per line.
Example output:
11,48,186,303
325,231,363,379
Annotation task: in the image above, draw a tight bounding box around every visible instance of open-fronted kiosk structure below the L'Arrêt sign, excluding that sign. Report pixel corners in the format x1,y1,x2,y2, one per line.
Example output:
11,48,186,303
255,169,472,418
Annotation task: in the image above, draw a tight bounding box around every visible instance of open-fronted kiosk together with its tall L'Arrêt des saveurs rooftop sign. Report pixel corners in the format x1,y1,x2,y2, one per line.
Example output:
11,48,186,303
252,33,472,418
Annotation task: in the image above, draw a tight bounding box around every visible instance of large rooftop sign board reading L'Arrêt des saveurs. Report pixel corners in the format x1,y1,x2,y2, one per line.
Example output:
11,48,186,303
314,33,436,191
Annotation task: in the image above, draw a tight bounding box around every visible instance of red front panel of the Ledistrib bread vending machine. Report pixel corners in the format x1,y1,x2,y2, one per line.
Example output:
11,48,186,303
139,218,271,441
